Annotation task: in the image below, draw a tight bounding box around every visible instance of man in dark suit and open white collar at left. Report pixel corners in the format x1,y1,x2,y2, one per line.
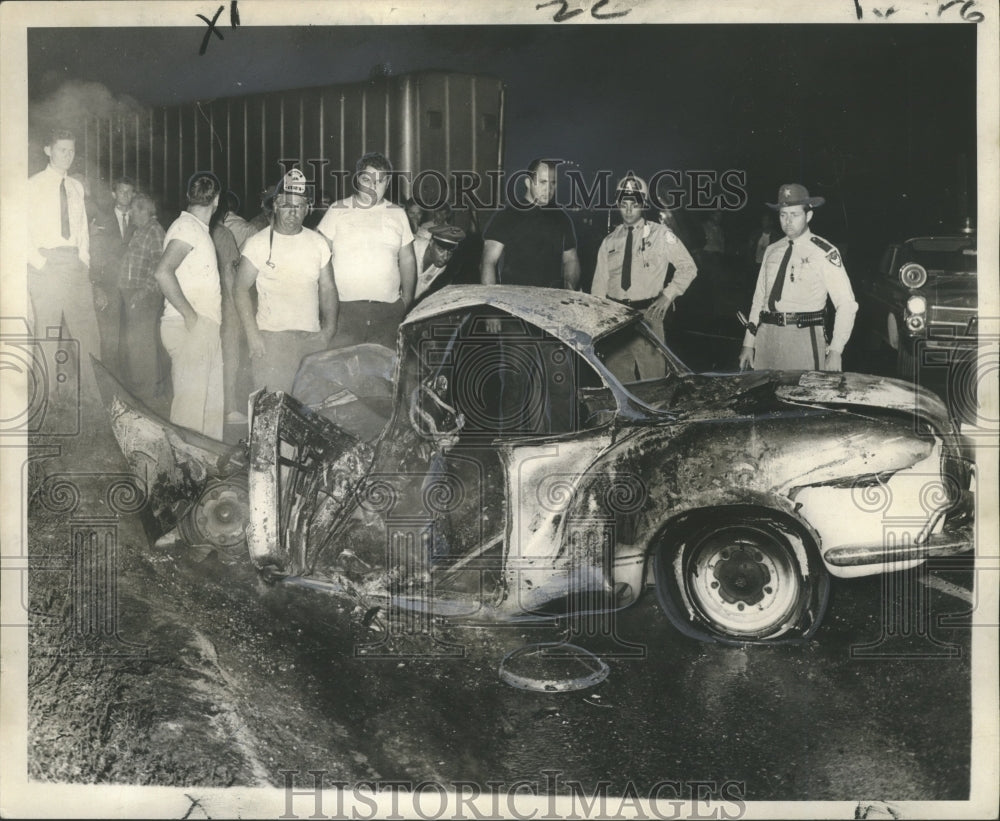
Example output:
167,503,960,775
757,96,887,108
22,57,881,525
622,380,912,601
90,177,135,377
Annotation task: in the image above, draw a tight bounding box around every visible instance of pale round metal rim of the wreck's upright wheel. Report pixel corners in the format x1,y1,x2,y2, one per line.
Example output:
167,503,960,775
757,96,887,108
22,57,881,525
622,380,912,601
683,527,805,638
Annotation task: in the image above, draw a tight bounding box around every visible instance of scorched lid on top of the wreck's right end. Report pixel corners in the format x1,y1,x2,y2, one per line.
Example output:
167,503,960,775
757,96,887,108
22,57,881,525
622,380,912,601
630,371,951,431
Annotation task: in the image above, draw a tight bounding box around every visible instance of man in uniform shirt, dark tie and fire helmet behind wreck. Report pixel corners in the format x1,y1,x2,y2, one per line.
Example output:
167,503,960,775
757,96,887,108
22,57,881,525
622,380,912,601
590,172,698,381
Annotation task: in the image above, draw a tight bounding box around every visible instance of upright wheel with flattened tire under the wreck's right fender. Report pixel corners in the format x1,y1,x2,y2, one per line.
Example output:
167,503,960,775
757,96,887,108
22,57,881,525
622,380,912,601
654,517,829,644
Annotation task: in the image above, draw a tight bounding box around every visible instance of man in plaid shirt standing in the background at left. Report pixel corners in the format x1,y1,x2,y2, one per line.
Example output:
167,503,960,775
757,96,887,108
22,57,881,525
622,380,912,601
118,194,165,404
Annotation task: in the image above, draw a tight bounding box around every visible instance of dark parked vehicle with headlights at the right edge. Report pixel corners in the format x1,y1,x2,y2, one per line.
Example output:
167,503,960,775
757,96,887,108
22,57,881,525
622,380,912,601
860,232,979,421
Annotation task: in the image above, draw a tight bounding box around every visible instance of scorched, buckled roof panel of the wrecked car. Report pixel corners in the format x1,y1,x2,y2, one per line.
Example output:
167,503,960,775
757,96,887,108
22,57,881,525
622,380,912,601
403,285,635,350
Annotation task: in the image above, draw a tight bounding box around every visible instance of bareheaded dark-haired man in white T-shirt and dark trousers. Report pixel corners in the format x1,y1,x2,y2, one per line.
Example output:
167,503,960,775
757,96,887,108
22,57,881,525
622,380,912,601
318,151,417,350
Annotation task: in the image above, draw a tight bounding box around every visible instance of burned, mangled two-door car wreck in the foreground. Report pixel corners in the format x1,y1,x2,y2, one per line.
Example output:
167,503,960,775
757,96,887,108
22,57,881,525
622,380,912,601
101,286,974,643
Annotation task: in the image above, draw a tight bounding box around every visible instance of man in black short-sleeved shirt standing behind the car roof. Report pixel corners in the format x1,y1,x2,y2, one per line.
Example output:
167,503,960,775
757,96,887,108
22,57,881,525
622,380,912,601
479,159,580,290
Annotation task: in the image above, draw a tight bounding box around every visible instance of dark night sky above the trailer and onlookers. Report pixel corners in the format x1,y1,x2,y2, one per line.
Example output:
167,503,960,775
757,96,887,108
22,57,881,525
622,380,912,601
28,25,976,250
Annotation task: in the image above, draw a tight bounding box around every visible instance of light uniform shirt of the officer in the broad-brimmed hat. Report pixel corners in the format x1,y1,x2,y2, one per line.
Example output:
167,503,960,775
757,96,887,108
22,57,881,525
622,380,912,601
743,229,858,353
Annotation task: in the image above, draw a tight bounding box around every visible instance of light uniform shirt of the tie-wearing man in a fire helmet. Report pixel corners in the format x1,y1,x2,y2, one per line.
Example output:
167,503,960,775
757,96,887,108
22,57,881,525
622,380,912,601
590,220,698,302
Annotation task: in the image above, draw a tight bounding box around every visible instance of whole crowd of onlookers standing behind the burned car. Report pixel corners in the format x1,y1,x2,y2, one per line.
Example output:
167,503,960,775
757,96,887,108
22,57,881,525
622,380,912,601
28,125,856,439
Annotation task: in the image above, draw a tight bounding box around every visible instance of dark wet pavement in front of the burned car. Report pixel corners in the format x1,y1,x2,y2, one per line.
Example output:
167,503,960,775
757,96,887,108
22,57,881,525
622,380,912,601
248,556,971,800
